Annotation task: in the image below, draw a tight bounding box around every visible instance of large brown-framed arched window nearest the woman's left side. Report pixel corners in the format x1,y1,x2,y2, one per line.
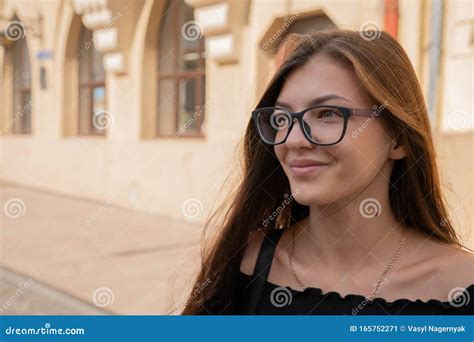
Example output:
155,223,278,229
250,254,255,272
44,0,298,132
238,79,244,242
157,0,206,137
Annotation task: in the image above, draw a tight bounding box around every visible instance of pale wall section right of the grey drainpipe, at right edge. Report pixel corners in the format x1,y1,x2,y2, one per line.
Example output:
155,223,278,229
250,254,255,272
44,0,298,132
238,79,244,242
437,1,474,249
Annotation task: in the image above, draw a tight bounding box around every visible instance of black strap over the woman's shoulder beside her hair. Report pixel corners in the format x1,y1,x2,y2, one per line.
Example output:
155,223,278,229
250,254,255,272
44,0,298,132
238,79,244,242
247,229,284,315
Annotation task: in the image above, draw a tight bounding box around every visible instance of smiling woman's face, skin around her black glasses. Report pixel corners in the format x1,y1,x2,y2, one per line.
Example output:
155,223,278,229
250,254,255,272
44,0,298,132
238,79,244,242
274,55,402,205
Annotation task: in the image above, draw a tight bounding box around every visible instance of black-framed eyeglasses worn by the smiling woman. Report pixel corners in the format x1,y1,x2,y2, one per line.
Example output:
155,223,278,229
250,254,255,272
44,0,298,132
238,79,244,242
252,106,383,146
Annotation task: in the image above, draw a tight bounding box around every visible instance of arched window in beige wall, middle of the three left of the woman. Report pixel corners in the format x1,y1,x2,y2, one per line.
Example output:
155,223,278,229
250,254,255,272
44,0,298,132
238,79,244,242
78,25,106,135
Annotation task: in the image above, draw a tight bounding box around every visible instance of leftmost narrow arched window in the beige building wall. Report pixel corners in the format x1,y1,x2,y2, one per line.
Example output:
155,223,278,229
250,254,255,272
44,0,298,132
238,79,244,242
11,32,32,134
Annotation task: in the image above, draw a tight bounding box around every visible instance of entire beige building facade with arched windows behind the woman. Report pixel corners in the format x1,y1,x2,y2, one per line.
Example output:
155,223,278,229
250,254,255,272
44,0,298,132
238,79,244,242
0,0,474,247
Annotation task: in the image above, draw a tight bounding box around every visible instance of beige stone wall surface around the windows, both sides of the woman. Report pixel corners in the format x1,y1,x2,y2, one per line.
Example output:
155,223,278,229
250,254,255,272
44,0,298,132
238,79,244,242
0,0,474,245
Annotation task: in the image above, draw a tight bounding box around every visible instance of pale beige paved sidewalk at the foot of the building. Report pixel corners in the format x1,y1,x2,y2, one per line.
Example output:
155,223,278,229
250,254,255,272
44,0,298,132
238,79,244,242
0,184,201,314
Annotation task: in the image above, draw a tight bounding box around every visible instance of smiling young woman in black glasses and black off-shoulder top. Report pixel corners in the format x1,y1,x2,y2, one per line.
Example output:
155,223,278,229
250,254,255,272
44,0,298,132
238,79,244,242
183,30,474,315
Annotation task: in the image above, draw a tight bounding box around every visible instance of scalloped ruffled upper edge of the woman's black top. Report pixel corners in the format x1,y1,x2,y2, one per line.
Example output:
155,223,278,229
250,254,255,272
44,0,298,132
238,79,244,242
240,271,474,308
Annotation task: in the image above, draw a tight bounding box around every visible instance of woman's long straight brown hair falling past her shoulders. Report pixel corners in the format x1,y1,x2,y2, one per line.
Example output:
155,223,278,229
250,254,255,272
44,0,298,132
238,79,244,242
183,30,462,314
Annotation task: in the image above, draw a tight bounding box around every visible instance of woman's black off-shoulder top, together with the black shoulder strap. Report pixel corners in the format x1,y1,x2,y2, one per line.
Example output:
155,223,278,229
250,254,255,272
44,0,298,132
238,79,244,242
233,229,474,315
